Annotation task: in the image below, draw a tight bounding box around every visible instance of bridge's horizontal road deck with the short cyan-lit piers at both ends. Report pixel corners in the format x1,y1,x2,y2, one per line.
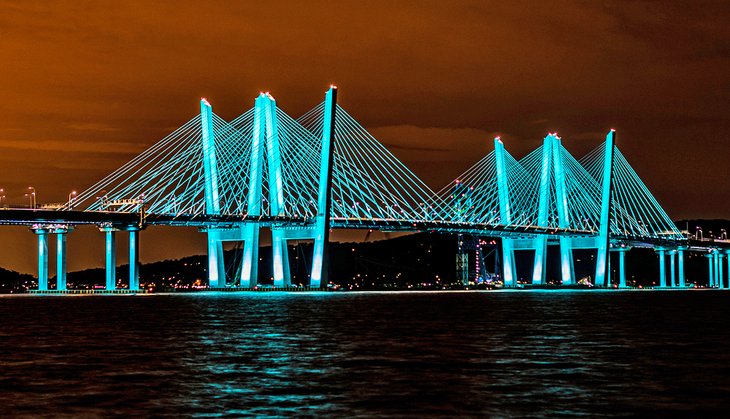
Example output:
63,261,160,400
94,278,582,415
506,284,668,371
0,208,730,291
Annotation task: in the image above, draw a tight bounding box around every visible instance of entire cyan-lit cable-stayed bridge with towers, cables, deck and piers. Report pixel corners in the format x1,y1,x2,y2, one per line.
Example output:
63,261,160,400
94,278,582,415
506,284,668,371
0,87,727,291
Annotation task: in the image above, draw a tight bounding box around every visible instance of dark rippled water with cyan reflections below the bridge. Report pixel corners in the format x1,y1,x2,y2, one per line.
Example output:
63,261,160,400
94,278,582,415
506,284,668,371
0,291,730,417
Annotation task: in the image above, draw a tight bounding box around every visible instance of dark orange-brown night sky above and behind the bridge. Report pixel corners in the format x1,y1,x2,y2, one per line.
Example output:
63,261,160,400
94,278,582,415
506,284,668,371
0,0,730,272
